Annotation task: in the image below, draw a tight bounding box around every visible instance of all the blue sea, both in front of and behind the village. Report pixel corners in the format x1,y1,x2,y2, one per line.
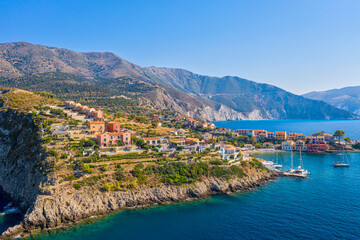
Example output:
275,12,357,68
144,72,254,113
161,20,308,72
0,120,360,240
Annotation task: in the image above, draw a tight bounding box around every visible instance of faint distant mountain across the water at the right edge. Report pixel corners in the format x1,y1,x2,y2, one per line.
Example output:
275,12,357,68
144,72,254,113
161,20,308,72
303,86,360,115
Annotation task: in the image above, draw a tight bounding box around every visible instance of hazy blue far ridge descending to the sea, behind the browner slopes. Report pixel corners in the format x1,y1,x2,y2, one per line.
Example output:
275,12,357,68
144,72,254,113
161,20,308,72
146,67,360,119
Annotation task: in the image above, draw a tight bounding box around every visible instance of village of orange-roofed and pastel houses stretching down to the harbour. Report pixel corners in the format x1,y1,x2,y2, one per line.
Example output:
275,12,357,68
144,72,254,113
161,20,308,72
43,101,356,167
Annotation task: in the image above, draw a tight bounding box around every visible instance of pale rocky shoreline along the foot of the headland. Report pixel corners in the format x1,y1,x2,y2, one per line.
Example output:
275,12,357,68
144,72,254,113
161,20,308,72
0,171,278,239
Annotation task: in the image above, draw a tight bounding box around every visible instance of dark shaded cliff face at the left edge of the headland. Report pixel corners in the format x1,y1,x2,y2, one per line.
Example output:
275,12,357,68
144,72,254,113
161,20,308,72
0,110,46,211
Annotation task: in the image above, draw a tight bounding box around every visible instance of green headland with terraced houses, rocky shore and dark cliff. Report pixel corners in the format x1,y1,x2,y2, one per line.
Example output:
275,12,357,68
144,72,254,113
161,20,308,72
0,88,276,239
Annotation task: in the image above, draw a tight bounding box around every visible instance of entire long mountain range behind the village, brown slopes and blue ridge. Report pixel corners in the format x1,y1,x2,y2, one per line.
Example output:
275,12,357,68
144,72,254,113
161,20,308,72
0,42,358,120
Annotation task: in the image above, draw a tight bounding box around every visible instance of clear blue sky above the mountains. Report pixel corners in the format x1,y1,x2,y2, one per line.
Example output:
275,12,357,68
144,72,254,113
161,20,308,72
0,0,360,94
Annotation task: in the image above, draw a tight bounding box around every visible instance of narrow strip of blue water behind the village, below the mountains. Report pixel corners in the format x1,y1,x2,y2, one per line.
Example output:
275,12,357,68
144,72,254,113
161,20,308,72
214,120,360,138
